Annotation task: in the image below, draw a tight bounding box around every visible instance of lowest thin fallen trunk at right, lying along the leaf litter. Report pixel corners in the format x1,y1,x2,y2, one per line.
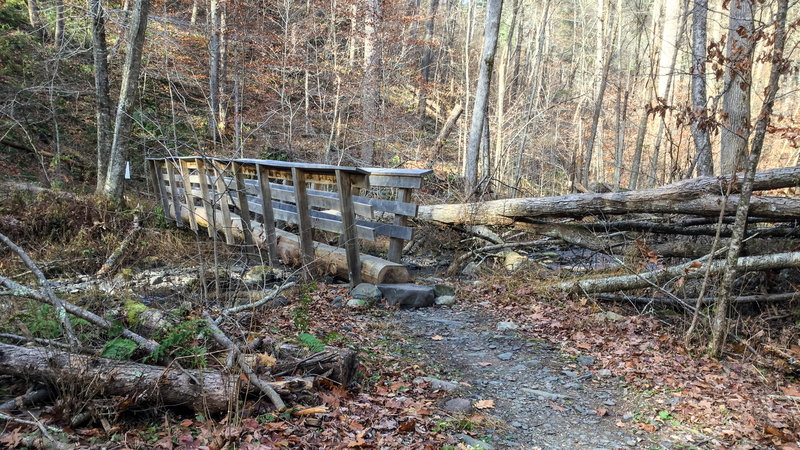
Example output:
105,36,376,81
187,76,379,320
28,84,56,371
552,252,800,294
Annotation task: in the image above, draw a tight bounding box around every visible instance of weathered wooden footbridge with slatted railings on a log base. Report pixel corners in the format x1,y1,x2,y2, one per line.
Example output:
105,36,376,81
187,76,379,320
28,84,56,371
147,156,431,285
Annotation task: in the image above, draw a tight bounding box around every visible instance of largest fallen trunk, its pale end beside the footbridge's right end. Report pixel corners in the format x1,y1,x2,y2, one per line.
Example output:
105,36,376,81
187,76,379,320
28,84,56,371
418,167,800,225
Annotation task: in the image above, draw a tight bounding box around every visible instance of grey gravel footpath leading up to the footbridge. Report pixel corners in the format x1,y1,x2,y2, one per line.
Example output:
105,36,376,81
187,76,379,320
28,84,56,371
394,304,651,449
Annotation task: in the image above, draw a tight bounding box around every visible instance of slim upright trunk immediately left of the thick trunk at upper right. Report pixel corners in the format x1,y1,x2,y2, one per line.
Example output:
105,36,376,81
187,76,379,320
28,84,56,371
692,0,714,177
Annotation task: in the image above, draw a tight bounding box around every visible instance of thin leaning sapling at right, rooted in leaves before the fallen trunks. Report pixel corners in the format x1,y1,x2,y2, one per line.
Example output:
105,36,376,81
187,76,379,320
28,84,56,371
709,0,788,356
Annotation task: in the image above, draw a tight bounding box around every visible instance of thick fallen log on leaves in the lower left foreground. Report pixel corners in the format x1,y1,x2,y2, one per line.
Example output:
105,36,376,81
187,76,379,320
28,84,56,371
0,335,358,413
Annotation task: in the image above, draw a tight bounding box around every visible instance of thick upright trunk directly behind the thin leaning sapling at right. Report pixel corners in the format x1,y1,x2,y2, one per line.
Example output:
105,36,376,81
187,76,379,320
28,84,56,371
720,0,754,174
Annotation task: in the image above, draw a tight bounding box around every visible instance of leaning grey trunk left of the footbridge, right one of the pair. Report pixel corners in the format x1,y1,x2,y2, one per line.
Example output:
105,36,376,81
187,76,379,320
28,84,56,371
103,0,150,200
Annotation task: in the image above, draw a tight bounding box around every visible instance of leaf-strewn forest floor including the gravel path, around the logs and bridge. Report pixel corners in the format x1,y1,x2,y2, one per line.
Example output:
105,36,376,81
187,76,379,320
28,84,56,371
0,188,800,449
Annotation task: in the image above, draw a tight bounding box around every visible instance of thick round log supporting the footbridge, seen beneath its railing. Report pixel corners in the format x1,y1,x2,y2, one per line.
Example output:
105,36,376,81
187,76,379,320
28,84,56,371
167,201,409,284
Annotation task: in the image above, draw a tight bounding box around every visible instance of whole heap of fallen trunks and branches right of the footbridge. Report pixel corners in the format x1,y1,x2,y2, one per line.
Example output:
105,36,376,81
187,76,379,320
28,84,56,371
418,167,800,294
